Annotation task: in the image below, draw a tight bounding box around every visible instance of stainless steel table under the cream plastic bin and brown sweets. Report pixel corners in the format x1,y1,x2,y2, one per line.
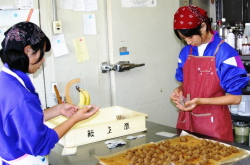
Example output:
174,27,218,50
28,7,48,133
49,121,250,165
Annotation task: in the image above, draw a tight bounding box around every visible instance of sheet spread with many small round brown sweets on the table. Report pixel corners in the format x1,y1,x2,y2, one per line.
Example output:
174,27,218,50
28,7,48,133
97,136,242,165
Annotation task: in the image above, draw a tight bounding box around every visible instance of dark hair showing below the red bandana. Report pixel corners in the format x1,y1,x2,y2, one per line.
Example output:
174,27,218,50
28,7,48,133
174,20,212,40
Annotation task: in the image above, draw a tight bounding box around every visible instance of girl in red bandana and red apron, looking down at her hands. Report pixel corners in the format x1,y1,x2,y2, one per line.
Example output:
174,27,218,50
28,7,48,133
170,5,249,141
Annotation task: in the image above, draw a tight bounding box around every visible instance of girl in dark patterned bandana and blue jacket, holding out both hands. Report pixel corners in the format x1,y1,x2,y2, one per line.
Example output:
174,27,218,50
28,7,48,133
0,22,99,165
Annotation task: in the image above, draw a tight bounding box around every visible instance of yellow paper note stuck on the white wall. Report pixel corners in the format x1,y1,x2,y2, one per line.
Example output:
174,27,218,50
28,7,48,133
74,37,89,63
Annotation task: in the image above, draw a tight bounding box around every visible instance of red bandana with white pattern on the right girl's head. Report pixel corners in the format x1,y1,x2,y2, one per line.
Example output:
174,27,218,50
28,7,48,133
174,5,208,29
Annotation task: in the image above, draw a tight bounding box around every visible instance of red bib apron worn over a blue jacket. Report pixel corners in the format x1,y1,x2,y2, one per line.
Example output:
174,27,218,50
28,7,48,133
176,41,234,141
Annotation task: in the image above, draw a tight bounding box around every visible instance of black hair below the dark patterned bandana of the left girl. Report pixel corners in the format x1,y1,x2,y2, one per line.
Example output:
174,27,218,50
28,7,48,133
0,37,51,73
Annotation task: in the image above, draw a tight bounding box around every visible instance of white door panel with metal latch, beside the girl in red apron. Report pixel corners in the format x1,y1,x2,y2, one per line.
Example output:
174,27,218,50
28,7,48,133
105,0,181,127
